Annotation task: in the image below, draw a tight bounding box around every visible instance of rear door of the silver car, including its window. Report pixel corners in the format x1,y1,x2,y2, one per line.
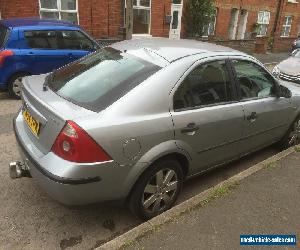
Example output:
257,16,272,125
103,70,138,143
171,58,244,174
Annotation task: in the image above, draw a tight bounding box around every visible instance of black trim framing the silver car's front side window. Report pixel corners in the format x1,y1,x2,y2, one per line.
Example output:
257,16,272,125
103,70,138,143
228,57,279,102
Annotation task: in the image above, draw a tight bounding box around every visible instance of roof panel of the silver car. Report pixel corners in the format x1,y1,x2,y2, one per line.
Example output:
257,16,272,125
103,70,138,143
111,38,244,63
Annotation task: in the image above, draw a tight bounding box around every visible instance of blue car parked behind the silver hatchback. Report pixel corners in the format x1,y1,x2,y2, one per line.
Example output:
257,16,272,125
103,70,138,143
0,19,99,98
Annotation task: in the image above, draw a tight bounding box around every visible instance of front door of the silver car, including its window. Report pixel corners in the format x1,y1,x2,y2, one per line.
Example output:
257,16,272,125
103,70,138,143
231,59,294,153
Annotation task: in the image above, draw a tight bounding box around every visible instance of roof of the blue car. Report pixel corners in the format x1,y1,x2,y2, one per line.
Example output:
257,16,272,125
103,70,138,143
0,18,78,28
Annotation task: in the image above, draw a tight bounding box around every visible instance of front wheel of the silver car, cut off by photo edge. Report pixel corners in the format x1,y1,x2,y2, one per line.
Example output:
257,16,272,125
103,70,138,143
279,116,300,150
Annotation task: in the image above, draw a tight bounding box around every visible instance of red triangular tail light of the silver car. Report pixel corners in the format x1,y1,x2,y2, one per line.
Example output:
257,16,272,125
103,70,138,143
51,121,111,163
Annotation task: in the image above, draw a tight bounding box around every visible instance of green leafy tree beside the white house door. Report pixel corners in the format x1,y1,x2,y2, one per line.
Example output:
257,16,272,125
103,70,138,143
184,0,216,37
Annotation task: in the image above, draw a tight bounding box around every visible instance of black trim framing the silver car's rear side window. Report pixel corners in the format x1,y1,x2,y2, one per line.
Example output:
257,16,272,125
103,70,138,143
172,56,238,112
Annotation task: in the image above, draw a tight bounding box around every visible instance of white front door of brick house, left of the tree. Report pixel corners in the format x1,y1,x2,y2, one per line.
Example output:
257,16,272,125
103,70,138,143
169,0,182,39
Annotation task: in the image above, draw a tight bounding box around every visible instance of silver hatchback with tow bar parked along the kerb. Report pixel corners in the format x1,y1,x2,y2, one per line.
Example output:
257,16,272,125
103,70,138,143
9,38,300,219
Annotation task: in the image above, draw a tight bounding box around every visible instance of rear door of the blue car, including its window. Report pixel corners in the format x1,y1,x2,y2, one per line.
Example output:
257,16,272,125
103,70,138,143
22,30,67,74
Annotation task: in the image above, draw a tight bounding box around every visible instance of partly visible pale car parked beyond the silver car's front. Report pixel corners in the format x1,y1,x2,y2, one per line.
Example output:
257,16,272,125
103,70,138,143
272,49,300,84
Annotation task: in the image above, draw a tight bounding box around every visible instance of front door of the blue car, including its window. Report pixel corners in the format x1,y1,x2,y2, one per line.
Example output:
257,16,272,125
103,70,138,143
59,30,96,63
